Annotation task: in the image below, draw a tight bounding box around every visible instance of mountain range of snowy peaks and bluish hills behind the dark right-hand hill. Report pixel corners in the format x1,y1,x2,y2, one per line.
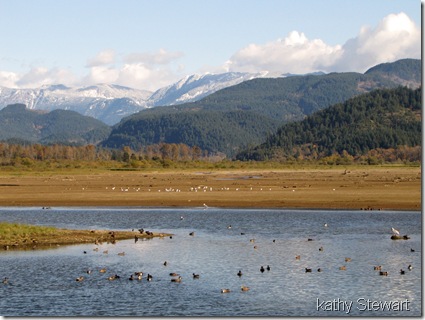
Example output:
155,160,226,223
0,59,422,157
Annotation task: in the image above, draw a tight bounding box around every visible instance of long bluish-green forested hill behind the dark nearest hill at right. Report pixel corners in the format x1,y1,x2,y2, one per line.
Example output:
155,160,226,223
103,59,421,156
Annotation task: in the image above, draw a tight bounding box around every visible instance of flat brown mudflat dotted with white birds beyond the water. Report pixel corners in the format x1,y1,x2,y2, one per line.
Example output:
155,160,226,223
0,166,421,210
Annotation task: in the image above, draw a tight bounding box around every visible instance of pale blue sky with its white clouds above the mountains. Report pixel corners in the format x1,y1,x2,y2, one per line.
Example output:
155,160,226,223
0,0,421,90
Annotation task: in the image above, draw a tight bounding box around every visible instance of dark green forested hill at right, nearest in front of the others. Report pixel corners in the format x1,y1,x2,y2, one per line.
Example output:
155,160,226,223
236,87,422,160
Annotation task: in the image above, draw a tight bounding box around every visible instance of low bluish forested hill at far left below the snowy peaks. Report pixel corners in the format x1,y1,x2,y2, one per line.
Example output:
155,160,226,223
0,104,111,145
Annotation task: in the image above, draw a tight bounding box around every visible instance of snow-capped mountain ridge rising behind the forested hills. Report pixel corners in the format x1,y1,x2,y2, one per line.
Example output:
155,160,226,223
0,72,266,125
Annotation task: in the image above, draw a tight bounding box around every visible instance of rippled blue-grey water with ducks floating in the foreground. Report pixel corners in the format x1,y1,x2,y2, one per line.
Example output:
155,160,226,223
0,208,422,317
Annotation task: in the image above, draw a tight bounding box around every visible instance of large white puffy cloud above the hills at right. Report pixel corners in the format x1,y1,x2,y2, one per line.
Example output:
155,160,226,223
224,13,421,73
